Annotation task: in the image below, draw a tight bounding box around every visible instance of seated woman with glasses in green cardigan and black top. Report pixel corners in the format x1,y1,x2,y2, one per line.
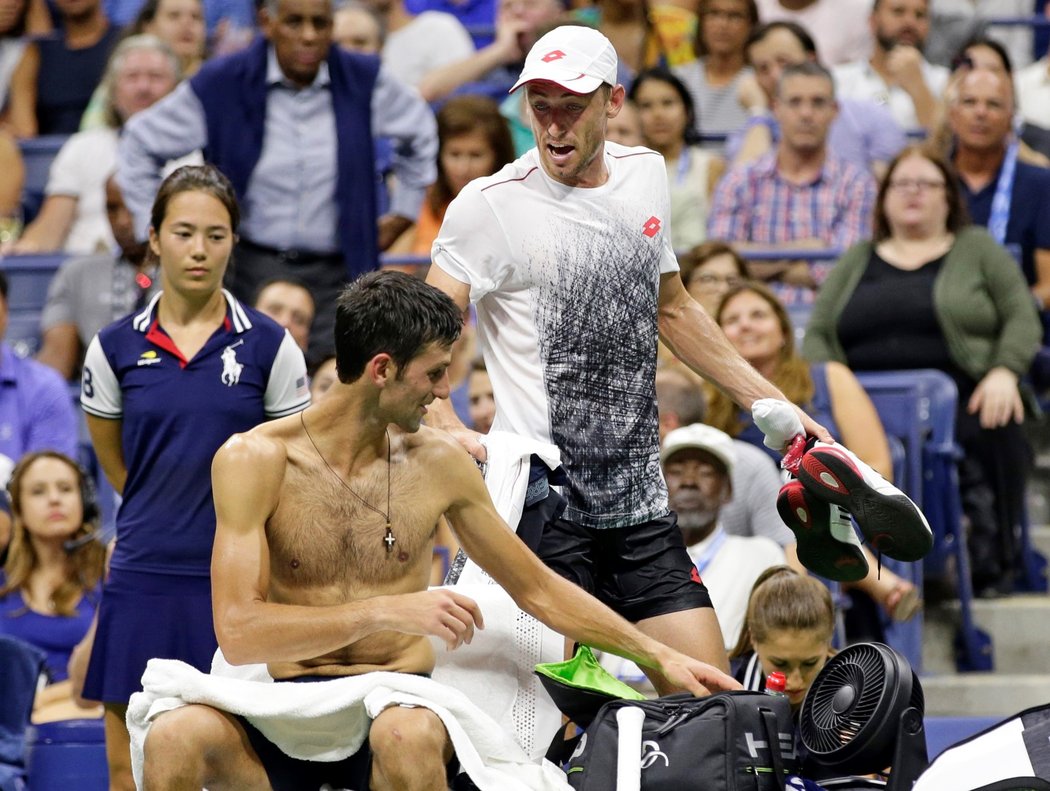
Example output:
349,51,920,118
802,147,1042,597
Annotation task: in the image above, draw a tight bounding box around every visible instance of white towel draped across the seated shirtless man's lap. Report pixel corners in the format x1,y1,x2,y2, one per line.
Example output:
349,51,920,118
127,657,570,791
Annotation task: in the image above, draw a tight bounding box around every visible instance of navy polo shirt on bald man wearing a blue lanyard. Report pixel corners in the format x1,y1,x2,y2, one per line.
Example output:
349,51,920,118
960,161,1050,285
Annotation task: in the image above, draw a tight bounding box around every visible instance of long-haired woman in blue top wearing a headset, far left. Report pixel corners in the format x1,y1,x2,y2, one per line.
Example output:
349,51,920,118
0,451,105,723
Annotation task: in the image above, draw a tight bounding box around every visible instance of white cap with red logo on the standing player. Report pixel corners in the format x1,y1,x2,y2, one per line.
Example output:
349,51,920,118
507,25,616,93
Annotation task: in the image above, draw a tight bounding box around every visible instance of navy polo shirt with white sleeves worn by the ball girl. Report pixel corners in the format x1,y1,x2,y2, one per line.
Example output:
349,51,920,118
81,292,310,576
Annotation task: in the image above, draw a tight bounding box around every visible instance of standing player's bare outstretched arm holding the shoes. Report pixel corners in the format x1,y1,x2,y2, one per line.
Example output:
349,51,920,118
657,272,832,442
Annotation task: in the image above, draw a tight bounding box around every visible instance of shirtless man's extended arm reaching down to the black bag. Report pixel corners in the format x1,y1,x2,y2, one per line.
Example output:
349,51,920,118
431,433,739,694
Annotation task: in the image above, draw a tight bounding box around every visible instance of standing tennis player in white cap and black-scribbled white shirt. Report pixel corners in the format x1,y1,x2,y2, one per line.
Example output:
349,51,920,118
427,26,828,693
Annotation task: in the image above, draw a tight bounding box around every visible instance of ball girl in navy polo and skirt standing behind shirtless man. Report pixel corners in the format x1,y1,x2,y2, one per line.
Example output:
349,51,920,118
81,165,310,789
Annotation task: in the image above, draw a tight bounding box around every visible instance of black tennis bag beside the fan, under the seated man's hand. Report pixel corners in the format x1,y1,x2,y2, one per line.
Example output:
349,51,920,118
566,692,798,791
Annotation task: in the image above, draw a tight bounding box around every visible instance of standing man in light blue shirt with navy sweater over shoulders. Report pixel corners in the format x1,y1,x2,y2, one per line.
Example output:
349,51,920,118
118,0,438,358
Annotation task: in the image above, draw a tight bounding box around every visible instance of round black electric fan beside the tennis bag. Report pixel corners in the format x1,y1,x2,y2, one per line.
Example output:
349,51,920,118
799,643,929,791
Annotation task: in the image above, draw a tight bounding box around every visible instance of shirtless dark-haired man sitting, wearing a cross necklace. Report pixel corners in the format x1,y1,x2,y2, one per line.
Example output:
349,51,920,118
145,272,738,791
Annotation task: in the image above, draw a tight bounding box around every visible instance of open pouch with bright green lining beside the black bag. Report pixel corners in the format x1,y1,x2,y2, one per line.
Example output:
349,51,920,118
533,645,646,728
